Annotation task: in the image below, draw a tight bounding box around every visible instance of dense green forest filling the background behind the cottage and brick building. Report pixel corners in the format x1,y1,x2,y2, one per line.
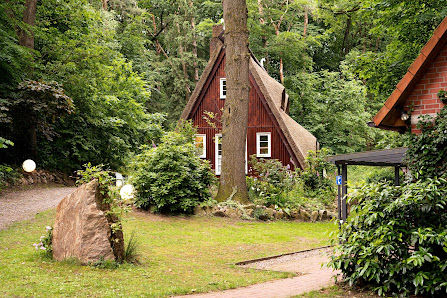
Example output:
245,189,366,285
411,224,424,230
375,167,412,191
0,0,447,171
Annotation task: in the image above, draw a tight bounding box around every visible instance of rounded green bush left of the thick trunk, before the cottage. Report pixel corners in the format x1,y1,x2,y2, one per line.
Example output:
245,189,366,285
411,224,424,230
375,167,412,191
132,122,214,213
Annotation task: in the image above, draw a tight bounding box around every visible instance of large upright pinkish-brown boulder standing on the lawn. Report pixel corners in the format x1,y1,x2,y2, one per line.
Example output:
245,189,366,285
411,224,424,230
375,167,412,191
53,180,115,264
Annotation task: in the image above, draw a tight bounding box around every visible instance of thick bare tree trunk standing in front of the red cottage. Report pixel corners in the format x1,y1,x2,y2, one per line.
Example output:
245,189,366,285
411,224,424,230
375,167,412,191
216,0,250,203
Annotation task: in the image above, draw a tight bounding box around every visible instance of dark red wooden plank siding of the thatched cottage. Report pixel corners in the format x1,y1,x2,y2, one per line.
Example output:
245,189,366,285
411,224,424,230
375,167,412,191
191,52,293,173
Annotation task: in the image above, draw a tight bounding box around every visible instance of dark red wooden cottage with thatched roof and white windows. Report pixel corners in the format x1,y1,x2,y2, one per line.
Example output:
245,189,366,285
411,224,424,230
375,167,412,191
181,26,318,175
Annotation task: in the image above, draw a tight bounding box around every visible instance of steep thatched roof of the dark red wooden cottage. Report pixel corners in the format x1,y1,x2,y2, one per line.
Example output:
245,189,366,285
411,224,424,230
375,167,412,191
181,39,319,168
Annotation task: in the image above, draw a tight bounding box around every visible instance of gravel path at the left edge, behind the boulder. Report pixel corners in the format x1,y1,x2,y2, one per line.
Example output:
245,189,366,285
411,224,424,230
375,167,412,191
0,185,76,230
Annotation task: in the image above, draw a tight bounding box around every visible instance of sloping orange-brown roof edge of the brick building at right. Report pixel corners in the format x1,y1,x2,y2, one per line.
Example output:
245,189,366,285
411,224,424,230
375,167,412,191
372,17,447,130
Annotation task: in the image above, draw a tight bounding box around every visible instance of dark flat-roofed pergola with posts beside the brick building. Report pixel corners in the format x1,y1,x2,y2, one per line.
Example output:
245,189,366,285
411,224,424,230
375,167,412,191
328,147,408,224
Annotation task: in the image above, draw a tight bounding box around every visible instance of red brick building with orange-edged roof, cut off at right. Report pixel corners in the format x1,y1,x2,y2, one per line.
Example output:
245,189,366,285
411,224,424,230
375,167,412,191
373,17,447,134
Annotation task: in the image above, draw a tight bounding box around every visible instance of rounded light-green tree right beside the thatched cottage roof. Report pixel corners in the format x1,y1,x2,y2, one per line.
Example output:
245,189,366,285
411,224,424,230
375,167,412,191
285,71,371,154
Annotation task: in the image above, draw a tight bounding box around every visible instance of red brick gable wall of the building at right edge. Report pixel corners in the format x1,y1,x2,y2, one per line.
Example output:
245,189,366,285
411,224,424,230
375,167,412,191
404,45,447,134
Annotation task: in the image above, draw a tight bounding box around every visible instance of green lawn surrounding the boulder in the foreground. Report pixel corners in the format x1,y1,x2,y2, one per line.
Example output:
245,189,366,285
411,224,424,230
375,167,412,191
0,210,336,297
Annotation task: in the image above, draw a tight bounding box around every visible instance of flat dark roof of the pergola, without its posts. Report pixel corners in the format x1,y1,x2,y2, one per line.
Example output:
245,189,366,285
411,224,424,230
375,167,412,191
328,147,408,167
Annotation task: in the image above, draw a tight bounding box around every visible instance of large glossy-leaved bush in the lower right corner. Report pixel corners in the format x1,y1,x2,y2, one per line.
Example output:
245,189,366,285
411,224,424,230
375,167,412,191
330,176,447,296
